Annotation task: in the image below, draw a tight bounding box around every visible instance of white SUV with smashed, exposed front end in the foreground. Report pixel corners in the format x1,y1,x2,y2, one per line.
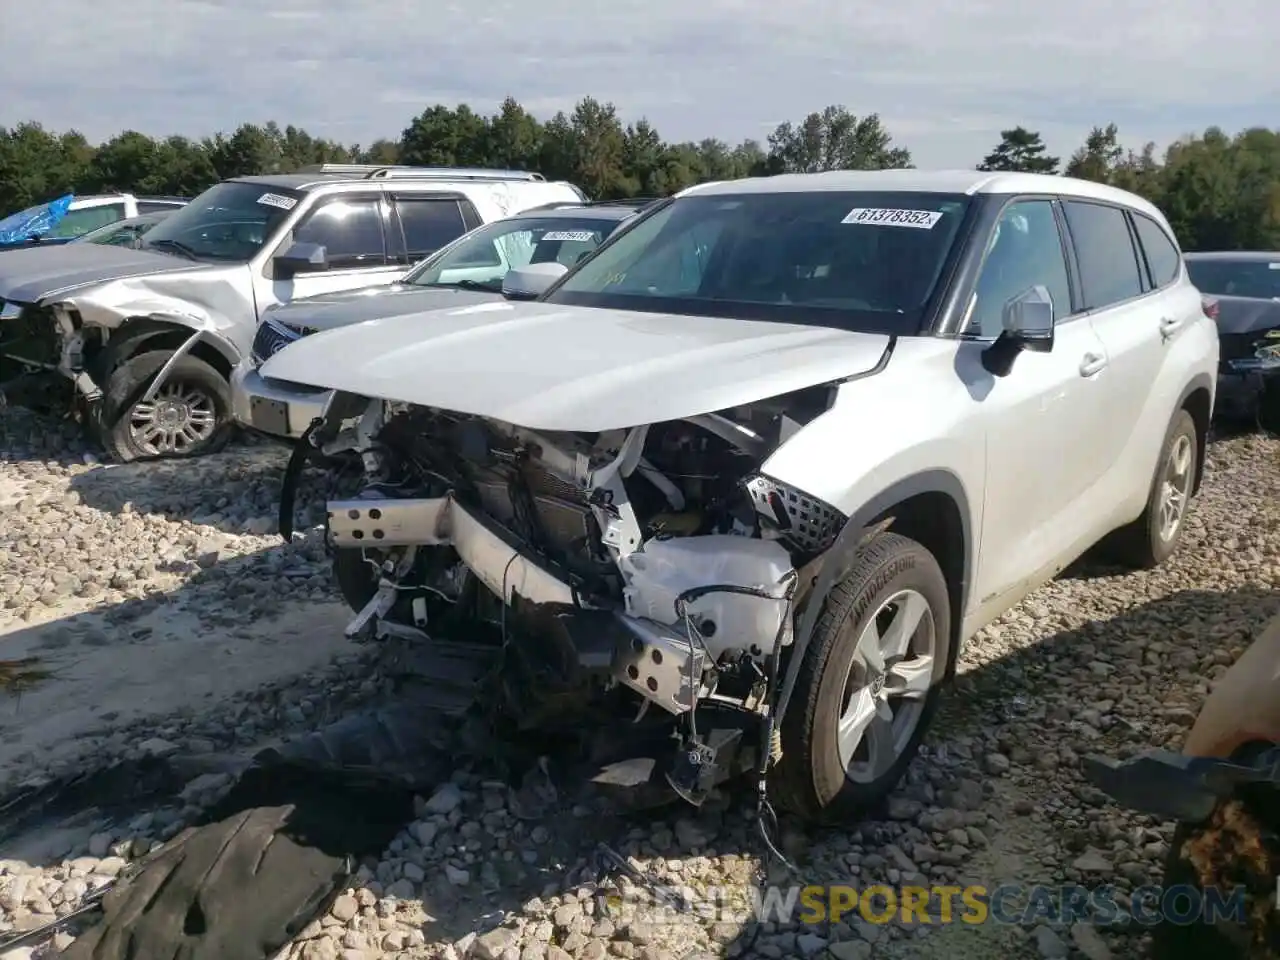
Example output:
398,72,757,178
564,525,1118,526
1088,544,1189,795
262,170,1219,820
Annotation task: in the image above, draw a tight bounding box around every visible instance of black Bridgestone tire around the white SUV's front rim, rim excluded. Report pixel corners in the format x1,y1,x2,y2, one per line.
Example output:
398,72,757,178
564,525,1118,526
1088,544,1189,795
771,534,951,823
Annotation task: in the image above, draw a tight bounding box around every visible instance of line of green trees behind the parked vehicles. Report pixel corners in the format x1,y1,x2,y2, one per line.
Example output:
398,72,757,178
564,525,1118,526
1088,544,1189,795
0,97,1280,250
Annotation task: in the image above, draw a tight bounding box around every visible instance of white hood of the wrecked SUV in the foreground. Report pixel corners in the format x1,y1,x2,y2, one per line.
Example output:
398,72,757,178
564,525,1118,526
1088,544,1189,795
260,301,888,431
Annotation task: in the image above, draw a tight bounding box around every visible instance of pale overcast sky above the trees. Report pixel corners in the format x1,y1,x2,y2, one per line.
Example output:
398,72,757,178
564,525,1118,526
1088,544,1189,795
0,0,1280,166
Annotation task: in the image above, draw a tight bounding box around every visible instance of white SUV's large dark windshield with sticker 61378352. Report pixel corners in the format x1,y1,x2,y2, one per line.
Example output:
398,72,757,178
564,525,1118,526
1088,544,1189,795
547,191,969,334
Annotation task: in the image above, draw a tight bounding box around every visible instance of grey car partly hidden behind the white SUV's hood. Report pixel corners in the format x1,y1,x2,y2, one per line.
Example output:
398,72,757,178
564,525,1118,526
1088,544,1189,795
232,200,652,440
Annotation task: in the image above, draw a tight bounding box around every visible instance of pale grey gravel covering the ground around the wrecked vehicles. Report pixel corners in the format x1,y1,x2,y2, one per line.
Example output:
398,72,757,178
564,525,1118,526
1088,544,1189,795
0,411,1280,960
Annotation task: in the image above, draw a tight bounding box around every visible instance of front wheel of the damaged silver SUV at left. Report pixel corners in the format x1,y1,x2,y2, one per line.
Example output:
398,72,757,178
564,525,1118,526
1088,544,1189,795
101,351,232,463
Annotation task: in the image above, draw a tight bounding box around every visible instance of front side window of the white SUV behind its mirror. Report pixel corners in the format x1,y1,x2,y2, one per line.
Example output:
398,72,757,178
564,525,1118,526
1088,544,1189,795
964,200,1071,339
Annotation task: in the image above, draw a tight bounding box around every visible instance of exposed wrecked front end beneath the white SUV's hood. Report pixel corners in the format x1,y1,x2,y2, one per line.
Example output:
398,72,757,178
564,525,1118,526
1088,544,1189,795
293,387,846,804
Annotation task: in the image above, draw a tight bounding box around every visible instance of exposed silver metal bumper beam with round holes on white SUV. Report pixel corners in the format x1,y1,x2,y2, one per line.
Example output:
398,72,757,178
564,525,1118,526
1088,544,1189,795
328,497,709,714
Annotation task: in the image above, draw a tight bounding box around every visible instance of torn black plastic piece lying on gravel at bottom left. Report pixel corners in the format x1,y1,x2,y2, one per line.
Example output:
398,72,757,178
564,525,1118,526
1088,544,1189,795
60,765,413,960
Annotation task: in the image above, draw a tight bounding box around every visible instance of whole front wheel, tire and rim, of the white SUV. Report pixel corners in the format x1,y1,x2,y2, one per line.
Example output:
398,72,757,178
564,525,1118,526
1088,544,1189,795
774,534,951,823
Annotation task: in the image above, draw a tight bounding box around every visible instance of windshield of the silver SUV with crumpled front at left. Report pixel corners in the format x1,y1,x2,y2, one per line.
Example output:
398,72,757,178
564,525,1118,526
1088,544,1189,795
142,182,300,261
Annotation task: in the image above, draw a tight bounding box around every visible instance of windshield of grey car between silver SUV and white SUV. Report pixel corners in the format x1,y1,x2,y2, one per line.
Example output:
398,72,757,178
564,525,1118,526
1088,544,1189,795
403,216,622,291
